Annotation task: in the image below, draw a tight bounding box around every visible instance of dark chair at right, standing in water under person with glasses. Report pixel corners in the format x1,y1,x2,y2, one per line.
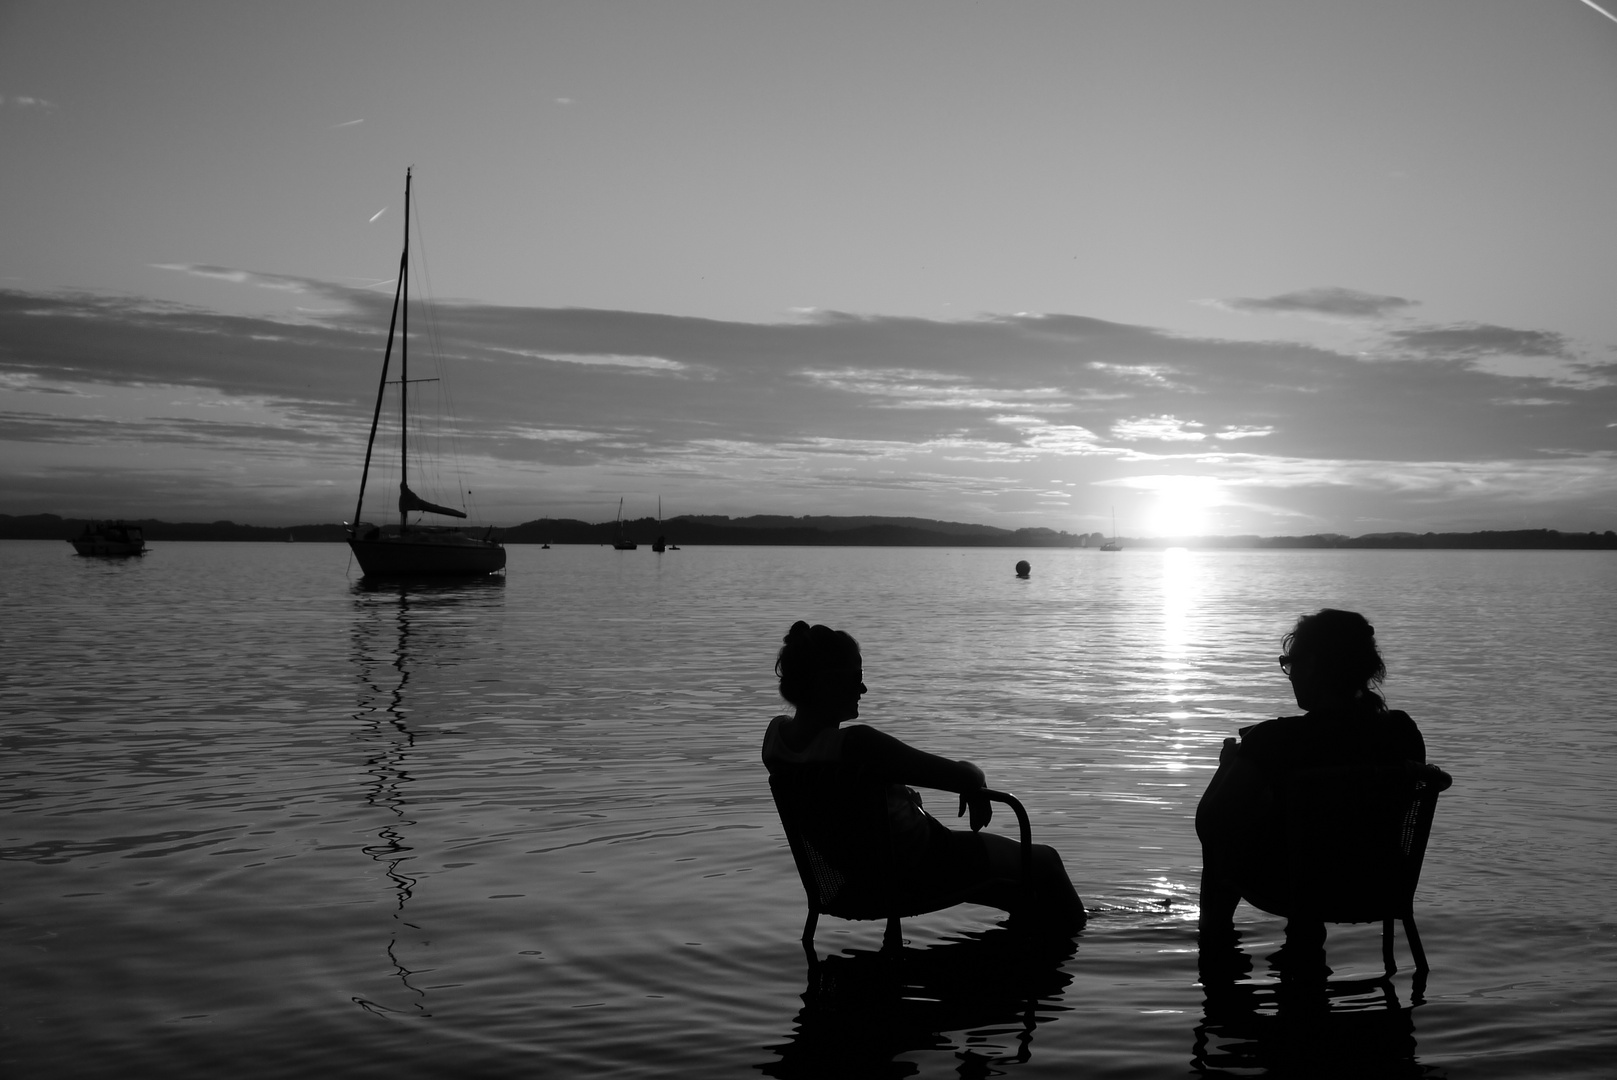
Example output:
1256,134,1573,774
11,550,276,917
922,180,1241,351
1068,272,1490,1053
1198,740,1454,980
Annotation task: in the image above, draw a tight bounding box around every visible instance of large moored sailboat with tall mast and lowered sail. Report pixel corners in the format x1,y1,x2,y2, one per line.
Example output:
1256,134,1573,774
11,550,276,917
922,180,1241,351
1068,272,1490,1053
348,170,505,577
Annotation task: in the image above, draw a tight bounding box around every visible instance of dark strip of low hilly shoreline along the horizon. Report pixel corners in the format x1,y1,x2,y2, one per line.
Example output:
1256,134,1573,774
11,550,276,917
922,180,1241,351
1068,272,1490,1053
0,514,1617,551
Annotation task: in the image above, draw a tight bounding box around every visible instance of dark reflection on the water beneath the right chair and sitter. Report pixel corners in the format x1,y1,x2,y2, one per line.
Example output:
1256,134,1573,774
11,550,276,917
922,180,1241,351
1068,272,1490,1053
1190,933,1434,1080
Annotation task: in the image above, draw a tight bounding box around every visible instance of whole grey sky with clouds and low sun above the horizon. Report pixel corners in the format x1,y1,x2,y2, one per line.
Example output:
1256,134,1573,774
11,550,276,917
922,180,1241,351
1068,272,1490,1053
0,0,1617,537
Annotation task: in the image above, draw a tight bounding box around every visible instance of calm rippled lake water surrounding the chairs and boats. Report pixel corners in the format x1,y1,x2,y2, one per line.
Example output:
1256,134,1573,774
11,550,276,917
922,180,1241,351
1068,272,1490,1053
0,542,1617,1078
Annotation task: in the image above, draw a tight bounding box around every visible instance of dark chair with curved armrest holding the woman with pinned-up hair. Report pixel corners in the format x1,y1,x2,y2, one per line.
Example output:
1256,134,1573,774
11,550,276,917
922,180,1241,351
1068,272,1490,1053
770,765,1033,957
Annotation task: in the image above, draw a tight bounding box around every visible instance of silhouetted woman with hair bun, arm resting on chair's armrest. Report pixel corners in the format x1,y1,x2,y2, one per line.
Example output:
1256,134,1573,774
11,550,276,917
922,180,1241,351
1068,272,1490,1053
763,621,1083,931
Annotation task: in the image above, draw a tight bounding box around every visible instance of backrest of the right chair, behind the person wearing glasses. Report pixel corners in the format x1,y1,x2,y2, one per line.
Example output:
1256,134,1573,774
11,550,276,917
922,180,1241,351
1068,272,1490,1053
1276,761,1454,923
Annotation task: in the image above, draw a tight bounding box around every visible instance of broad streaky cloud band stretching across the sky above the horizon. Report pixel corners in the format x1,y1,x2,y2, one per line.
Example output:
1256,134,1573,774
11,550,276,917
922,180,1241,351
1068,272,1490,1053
0,278,1617,532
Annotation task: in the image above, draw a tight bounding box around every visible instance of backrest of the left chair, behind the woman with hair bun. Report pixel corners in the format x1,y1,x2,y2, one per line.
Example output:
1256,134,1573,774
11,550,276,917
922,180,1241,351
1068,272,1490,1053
770,765,894,918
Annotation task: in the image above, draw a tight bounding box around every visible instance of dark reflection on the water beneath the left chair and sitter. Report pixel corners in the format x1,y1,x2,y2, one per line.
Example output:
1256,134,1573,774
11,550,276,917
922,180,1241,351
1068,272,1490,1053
758,928,1077,1080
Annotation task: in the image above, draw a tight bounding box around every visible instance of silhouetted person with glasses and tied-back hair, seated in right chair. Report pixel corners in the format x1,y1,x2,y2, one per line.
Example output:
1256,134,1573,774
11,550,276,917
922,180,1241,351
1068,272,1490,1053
1197,608,1426,952
